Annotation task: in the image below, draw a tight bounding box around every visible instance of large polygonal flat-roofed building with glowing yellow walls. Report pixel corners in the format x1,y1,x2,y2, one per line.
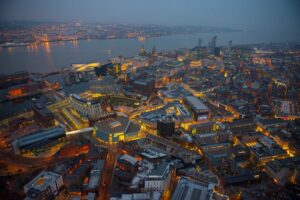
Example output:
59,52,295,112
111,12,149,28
94,116,140,143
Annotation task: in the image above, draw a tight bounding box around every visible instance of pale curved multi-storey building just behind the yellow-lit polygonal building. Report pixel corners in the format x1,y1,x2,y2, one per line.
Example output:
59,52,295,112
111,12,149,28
69,94,115,121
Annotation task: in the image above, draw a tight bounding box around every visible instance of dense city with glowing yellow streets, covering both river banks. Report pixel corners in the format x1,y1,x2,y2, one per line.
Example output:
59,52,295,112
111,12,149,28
0,0,300,200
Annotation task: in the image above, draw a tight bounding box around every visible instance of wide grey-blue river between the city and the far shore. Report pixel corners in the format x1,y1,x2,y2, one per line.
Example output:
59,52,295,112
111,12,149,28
0,31,300,73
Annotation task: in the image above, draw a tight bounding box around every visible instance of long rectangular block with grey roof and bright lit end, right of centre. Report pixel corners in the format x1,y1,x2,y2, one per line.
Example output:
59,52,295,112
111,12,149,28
184,96,211,121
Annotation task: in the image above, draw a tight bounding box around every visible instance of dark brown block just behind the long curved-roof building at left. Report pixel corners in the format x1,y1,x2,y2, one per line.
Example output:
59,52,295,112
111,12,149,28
33,104,55,127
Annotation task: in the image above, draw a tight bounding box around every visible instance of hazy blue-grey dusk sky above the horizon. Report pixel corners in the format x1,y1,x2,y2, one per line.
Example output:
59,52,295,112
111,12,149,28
0,0,300,32
